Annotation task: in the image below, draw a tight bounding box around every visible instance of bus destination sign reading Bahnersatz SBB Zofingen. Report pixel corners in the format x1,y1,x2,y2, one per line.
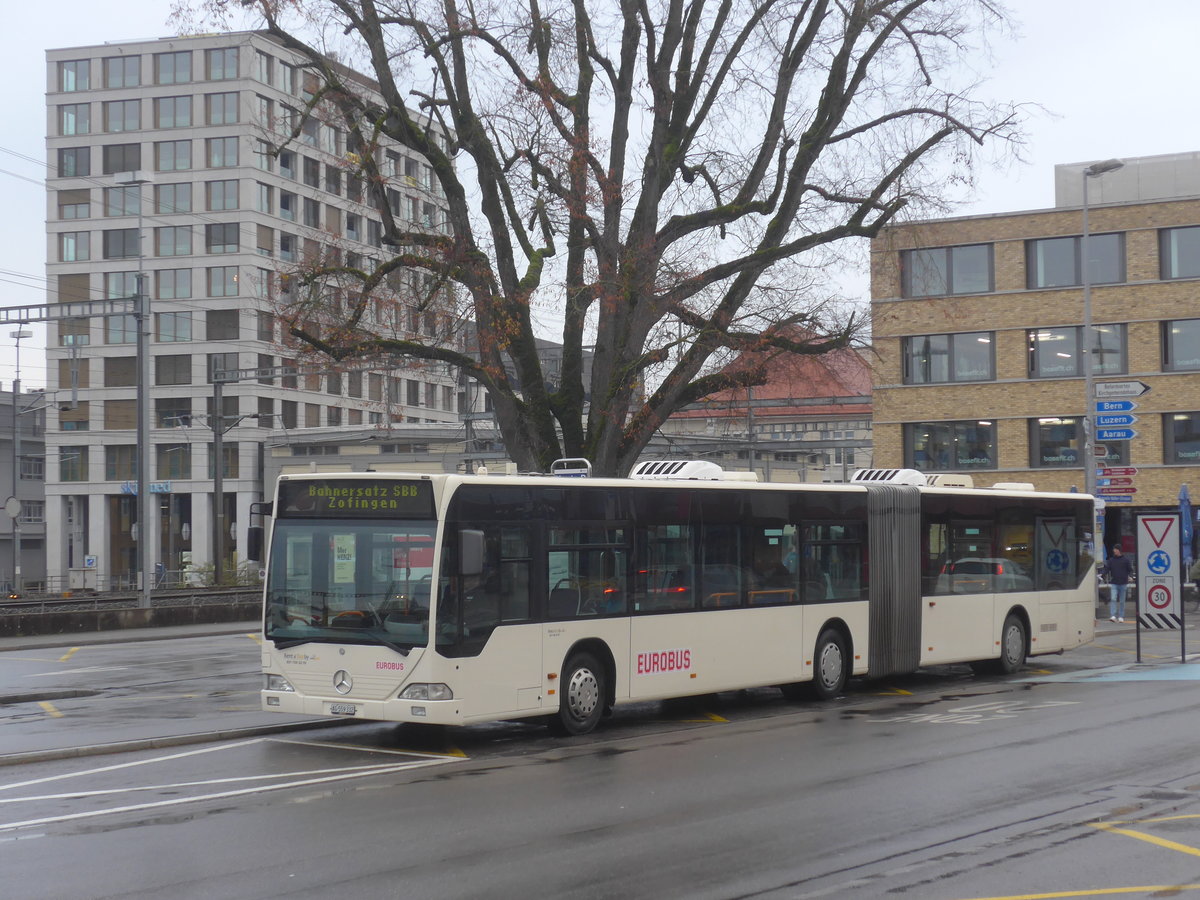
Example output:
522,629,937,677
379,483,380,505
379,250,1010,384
277,478,433,518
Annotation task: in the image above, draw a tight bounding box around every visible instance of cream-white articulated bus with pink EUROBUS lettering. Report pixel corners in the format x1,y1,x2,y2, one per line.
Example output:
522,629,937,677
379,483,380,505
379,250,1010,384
263,462,1096,734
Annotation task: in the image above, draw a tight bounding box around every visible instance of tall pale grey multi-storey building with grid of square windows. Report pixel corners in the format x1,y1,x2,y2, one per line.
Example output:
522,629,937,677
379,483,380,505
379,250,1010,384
46,32,458,587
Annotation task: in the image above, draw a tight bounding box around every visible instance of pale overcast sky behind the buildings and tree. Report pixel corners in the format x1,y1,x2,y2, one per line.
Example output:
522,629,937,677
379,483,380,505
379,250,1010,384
0,0,1200,389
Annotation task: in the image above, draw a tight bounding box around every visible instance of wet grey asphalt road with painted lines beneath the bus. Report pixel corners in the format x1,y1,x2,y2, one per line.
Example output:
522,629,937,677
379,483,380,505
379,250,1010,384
0,623,1200,900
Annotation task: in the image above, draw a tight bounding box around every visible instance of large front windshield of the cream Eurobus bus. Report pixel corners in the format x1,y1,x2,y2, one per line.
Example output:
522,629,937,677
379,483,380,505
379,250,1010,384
265,518,436,653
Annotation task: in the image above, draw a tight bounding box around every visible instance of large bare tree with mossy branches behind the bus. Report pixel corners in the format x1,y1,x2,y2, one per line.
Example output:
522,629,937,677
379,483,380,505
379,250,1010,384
185,0,1019,474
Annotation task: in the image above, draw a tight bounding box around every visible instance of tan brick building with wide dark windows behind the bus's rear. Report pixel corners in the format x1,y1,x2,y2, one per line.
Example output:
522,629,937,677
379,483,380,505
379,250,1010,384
871,154,1200,547
